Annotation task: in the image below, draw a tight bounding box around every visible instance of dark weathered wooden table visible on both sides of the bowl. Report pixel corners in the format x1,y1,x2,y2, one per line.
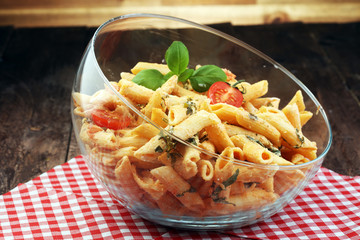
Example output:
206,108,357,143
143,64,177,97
0,23,360,194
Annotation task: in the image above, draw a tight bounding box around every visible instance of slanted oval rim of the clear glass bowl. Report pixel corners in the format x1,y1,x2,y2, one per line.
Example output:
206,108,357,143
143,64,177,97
88,13,333,170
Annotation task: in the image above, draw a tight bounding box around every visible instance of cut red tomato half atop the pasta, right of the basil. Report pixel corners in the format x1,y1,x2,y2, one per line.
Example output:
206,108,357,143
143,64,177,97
207,82,243,107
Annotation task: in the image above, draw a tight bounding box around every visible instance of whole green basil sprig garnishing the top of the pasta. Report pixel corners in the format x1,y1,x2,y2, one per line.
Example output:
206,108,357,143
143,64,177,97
133,41,226,92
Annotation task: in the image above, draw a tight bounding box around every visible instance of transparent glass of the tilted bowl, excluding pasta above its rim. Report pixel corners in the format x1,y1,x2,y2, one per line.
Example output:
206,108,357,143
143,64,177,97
72,14,332,230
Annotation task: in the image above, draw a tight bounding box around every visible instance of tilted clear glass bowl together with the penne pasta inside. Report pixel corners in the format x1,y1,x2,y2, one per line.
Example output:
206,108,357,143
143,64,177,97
72,14,332,230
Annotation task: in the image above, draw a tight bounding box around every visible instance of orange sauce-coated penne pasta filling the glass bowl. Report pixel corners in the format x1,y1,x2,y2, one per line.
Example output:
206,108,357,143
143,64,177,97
73,63,317,217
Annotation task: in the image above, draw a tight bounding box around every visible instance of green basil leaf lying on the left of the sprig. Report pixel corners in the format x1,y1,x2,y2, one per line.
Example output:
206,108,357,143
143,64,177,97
132,69,166,90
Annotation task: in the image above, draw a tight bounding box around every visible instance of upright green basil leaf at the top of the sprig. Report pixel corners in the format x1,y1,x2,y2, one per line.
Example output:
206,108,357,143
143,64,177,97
165,41,189,75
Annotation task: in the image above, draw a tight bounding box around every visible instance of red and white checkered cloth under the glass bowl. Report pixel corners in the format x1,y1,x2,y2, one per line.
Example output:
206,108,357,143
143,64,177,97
0,157,360,239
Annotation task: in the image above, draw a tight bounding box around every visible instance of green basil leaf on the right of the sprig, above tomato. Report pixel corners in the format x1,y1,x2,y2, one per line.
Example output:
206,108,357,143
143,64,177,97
189,65,226,92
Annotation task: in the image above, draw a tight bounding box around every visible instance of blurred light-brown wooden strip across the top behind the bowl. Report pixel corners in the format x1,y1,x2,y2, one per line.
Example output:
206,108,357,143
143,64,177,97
0,0,360,27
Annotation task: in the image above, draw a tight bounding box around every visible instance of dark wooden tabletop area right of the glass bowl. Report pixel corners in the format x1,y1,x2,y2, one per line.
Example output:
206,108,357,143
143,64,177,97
235,24,360,176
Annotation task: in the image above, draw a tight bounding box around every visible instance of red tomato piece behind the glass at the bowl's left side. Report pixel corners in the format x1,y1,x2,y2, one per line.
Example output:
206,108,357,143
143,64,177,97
91,109,131,130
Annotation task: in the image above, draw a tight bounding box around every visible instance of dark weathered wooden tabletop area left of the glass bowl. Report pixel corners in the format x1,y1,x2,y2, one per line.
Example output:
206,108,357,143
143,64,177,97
0,28,89,194
